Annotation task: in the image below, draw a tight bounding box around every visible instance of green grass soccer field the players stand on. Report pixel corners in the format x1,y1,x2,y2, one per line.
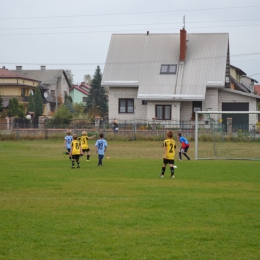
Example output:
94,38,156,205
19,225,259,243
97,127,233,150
0,140,260,260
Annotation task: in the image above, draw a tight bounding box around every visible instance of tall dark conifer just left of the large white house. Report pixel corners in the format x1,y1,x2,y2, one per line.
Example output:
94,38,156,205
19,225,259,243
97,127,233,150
86,66,108,118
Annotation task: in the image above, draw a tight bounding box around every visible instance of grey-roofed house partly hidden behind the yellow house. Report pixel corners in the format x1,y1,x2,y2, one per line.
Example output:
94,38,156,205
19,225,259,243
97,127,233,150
14,66,71,115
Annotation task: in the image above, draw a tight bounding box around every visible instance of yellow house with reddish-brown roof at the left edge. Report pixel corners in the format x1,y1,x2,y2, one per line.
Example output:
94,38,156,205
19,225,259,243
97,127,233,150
0,68,40,112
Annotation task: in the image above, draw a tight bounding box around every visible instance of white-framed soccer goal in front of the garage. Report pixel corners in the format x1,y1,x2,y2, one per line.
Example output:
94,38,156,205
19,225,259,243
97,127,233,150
195,111,260,160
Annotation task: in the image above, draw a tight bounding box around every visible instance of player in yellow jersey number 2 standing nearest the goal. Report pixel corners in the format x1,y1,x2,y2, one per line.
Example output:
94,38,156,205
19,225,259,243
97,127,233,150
160,131,176,178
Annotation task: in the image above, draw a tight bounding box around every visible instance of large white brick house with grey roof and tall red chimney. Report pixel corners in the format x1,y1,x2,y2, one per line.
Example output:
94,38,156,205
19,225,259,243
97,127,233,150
101,29,259,124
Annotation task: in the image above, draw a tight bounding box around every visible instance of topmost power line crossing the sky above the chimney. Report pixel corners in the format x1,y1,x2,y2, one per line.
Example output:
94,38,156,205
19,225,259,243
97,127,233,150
0,5,260,20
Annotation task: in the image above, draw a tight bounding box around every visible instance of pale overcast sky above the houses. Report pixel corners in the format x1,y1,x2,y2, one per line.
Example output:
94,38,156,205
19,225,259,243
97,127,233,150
0,0,260,84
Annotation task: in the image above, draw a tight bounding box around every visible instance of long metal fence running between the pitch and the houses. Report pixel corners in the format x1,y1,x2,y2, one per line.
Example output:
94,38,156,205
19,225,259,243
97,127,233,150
0,118,260,140
